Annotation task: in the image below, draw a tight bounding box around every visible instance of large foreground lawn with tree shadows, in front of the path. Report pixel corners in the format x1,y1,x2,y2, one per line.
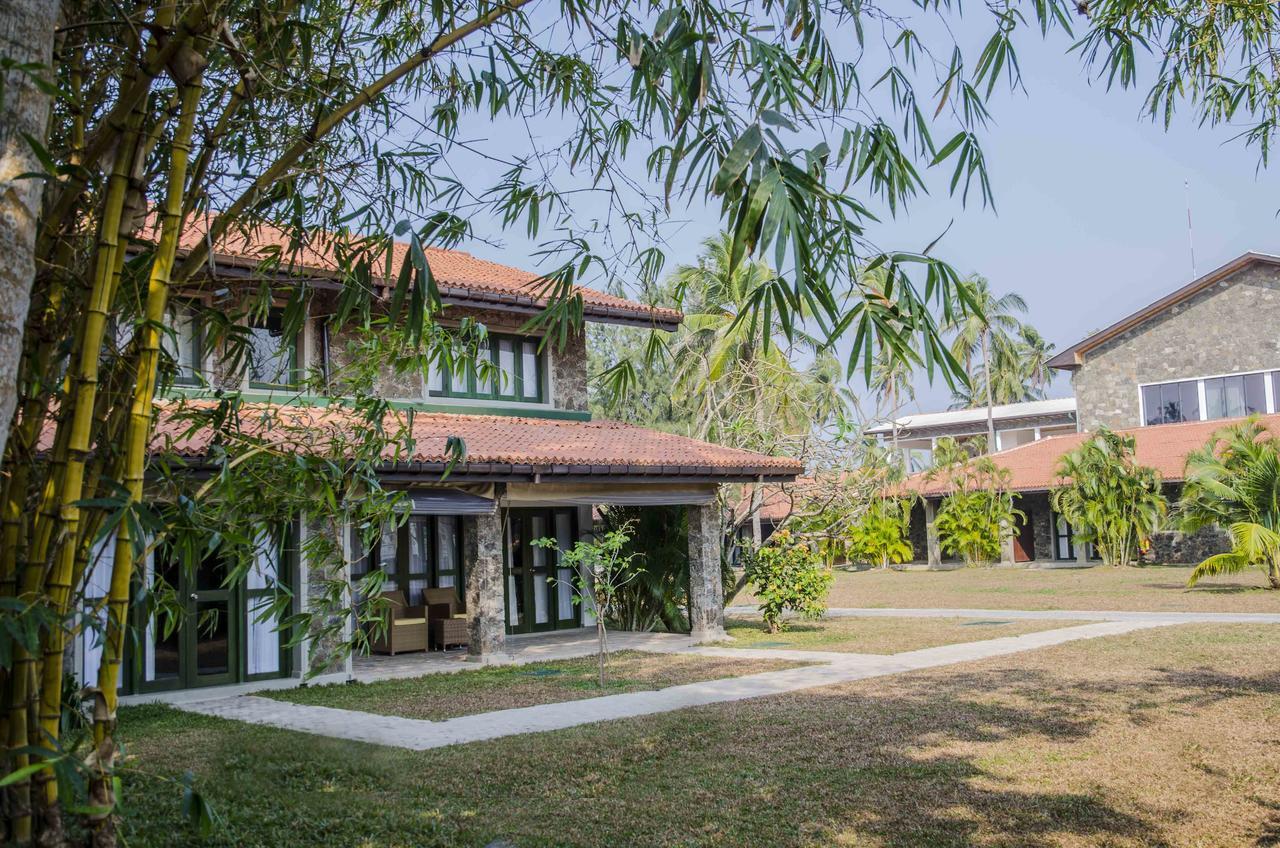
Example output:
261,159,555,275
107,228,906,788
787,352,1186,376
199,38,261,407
120,625,1280,848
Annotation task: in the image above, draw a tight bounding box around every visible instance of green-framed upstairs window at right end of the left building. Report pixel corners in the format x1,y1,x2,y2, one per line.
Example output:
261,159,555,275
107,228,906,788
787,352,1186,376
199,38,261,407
426,333,547,404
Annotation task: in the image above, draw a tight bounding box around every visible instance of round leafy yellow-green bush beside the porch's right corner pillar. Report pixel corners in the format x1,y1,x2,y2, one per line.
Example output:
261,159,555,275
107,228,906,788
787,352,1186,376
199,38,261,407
746,528,832,633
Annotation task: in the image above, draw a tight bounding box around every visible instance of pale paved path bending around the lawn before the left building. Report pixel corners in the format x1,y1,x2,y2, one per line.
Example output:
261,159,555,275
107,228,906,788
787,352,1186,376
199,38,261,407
179,611,1172,751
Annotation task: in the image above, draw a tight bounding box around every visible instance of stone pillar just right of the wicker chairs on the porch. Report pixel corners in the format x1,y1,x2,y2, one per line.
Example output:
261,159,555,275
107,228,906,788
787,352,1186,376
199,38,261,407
462,509,509,662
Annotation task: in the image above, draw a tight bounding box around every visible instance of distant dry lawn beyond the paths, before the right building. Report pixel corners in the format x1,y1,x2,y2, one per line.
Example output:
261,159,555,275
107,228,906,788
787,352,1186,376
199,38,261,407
733,565,1280,612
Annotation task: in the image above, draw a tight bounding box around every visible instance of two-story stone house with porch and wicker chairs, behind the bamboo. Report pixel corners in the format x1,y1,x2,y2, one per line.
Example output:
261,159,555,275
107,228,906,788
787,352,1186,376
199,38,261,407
74,225,801,694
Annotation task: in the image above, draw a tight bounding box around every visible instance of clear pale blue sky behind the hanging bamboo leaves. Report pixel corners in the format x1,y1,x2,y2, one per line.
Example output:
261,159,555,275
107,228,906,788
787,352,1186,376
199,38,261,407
432,6,1280,412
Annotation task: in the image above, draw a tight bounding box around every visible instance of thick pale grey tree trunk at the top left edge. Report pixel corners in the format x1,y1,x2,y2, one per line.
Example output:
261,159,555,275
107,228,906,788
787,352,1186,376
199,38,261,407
0,0,59,466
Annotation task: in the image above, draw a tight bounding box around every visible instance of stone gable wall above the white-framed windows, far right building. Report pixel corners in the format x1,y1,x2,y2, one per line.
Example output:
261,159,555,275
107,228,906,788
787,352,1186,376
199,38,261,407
1071,264,1280,430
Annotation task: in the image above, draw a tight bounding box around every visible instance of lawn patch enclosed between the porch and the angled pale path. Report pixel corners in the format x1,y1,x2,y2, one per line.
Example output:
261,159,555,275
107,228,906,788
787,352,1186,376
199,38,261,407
257,651,806,721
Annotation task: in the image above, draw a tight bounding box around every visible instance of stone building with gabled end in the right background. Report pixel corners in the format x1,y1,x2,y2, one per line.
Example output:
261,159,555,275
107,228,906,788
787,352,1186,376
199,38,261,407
909,252,1280,565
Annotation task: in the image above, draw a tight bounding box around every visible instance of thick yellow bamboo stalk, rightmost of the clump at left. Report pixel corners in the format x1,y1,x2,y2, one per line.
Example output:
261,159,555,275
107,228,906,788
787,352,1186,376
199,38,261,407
91,77,201,844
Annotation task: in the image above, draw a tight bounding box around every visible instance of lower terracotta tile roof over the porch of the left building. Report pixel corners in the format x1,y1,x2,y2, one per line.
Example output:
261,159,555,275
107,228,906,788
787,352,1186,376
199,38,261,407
152,400,803,479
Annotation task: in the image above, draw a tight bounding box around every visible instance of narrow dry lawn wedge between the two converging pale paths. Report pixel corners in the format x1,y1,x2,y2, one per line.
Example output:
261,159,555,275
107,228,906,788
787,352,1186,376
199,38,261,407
724,617,1085,653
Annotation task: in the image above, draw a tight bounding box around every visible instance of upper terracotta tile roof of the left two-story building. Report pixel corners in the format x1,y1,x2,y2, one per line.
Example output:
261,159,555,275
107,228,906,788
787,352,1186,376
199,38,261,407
142,216,684,329
